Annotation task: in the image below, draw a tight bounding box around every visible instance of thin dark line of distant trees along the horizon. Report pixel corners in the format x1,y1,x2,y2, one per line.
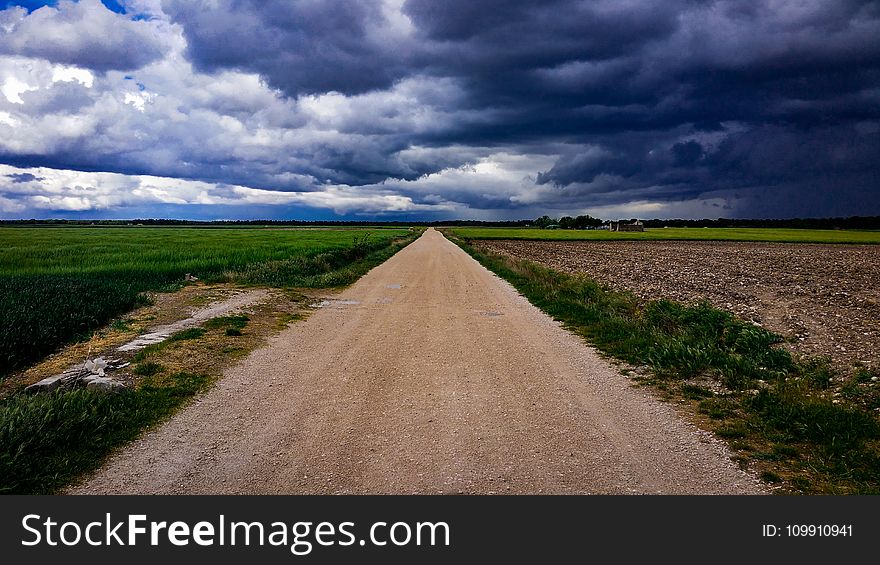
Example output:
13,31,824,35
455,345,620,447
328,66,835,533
0,215,880,230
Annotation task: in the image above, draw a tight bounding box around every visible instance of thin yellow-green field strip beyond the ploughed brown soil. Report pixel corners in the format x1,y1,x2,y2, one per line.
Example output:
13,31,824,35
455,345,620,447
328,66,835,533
451,228,880,244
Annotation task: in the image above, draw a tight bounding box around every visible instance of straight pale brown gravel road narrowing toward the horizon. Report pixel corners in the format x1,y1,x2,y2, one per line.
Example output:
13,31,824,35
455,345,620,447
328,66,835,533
70,230,762,494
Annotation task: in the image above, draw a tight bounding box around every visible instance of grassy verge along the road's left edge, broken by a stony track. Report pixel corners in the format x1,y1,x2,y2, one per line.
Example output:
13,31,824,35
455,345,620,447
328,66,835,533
0,227,418,494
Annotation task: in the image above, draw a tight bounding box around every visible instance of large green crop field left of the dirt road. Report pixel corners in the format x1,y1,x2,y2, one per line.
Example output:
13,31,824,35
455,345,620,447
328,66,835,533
0,227,409,378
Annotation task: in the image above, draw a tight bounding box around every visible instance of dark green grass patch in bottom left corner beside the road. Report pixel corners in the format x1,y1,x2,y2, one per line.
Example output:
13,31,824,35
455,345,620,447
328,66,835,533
0,373,212,494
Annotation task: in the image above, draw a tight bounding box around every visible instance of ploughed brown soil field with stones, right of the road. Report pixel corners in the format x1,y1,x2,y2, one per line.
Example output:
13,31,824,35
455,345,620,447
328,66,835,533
482,241,880,373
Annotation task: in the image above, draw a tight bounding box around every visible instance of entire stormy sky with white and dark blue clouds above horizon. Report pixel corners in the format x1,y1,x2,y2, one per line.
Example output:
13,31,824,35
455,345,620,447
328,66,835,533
0,0,880,219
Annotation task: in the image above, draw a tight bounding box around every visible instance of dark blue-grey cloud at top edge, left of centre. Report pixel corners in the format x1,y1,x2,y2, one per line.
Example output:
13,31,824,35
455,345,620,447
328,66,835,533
164,0,408,95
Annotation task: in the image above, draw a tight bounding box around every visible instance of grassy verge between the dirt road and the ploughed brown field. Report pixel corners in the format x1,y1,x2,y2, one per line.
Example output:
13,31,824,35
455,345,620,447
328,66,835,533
454,234,880,494
